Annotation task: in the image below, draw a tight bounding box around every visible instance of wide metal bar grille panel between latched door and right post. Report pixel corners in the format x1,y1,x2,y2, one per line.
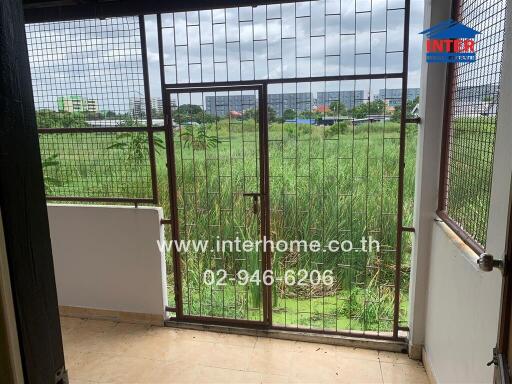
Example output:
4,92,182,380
268,80,410,334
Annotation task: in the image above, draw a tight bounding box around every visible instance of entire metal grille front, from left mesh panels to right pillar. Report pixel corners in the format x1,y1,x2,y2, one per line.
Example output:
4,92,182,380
23,0,416,340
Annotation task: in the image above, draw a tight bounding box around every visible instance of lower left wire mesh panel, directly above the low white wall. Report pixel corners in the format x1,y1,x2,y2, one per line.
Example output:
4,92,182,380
39,131,152,202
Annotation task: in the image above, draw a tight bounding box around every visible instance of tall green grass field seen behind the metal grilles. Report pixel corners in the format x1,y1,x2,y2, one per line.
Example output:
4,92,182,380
41,120,417,331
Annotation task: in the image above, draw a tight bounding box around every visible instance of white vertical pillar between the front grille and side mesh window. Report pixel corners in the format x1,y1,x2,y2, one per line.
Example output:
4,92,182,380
409,0,451,359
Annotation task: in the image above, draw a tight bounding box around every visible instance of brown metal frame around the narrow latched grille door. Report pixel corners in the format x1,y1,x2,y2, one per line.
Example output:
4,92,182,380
162,84,272,328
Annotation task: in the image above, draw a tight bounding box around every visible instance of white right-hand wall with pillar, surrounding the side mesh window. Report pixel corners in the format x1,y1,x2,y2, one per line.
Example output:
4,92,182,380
411,0,512,383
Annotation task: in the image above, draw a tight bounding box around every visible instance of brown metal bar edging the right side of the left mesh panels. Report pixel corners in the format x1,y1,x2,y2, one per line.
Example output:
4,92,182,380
139,15,159,205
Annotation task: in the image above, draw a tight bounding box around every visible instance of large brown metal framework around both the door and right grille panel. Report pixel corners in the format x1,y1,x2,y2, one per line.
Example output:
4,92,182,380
157,0,412,341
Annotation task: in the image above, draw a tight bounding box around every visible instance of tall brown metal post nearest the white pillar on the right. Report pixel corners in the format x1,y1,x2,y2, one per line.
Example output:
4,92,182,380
393,0,411,338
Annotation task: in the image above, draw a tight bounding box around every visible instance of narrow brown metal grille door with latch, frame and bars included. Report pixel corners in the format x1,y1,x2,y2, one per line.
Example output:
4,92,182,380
167,86,268,324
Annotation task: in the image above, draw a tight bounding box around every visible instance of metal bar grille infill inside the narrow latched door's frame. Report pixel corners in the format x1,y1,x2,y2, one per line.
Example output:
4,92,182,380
171,90,263,321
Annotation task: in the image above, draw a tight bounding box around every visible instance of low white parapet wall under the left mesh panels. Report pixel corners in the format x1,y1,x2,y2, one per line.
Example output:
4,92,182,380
48,204,167,322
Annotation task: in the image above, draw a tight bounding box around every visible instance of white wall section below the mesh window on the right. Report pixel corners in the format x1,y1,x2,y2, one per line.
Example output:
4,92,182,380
425,223,501,383
